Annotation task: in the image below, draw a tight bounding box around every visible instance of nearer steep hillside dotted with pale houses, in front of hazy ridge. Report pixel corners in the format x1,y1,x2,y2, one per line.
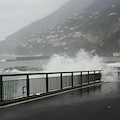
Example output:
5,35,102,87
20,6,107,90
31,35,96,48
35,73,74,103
16,0,120,56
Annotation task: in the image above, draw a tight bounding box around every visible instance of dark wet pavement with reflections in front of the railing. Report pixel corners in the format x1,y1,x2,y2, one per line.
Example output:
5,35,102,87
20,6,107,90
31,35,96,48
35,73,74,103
0,81,120,120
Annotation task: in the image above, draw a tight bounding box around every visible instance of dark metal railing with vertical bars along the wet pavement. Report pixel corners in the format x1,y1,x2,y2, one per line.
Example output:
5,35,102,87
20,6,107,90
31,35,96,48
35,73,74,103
0,70,101,101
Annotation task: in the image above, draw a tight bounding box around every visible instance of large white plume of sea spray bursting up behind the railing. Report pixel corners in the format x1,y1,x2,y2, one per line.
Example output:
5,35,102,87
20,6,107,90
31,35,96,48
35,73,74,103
44,49,103,72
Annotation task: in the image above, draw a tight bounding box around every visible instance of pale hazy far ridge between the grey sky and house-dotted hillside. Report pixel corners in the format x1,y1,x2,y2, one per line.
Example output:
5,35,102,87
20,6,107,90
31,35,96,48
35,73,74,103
0,0,94,54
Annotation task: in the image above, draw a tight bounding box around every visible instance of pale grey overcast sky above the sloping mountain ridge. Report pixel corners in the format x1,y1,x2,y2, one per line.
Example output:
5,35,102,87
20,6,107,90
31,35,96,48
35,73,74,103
0,0,68,40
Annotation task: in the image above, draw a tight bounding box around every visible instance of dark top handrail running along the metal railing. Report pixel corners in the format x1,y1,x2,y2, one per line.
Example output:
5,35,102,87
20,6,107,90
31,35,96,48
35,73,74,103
0,70,102,77
